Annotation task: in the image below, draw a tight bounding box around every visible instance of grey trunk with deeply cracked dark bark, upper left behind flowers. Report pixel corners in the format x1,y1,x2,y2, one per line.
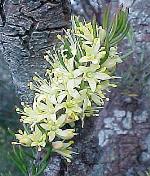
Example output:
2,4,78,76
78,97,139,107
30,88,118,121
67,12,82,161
0,0,70,101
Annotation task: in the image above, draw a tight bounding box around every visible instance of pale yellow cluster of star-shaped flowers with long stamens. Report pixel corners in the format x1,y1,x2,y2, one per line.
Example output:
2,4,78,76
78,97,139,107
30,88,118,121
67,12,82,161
13,16,121,161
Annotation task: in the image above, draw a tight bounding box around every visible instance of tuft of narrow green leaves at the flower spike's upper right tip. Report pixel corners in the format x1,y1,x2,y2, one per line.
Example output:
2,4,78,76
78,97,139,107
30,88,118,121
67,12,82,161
100,7,130,64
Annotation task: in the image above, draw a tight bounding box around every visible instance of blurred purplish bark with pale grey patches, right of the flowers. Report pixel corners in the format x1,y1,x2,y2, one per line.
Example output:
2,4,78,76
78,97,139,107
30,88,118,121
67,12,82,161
96,0,150,176
